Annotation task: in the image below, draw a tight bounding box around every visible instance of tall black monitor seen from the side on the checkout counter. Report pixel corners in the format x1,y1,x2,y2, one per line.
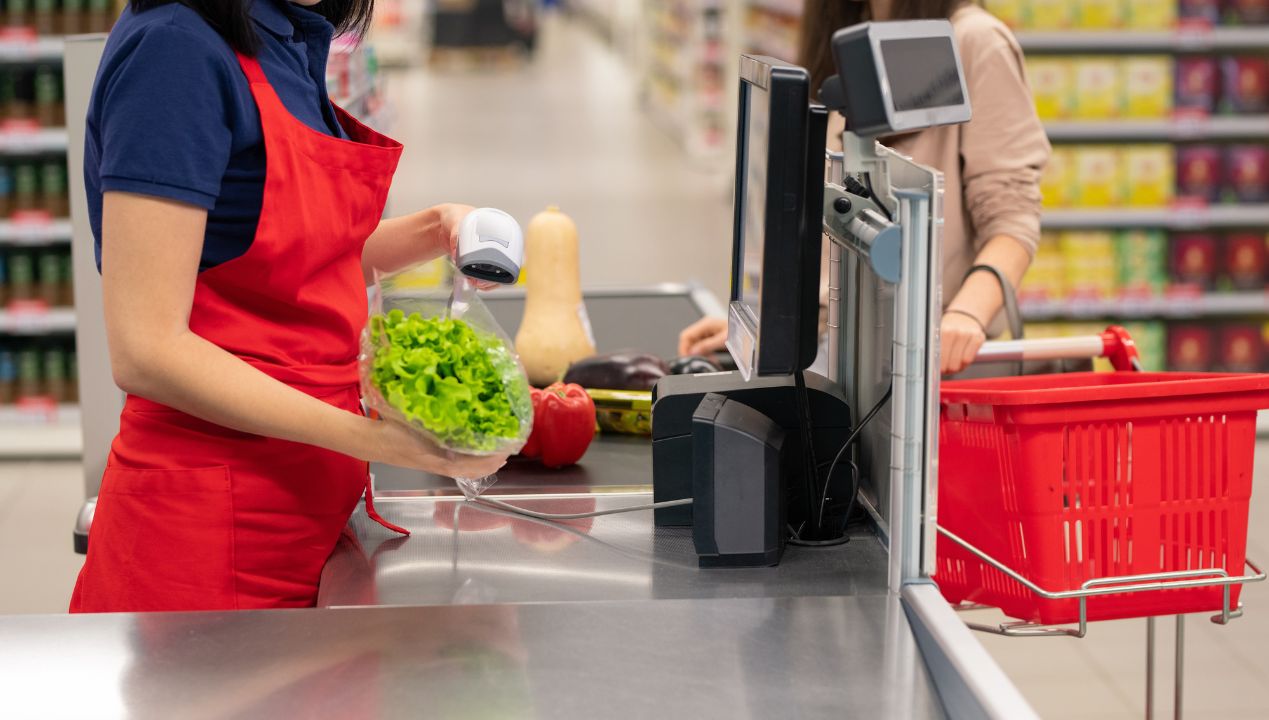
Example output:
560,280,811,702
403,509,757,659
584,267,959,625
727,55,827,380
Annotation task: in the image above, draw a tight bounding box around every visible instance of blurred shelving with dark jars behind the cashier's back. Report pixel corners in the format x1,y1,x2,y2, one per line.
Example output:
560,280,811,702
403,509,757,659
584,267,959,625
0,0,92,457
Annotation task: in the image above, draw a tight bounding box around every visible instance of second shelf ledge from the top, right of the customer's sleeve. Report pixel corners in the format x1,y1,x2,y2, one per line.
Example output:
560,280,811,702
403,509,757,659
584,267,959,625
1044,116,1269,142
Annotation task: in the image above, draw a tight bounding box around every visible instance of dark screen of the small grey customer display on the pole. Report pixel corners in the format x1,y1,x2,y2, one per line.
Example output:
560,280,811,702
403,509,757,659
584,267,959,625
881,37,964,112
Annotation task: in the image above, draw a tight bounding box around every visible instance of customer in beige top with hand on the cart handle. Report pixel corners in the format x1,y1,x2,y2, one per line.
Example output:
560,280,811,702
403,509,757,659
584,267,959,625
679,0,1049,373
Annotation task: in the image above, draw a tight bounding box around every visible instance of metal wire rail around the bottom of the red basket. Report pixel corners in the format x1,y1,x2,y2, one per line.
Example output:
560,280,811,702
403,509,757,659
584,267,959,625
935,526,1265,637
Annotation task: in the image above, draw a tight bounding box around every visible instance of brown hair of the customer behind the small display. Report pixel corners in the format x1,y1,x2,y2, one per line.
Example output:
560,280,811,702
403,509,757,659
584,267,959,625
798,0,966,95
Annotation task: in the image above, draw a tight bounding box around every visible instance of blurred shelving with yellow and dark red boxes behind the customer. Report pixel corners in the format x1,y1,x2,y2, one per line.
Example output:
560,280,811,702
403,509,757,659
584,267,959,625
986,0,1269,371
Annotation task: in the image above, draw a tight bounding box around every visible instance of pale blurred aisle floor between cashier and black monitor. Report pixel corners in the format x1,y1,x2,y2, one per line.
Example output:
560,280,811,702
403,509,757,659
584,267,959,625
387,18,731,300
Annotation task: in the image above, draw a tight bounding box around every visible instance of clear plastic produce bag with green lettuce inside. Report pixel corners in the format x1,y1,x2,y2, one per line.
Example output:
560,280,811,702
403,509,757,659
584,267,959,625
359,263,533,499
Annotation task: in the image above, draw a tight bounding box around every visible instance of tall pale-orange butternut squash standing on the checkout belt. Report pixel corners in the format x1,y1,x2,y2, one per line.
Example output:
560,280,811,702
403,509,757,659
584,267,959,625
515,206,595,387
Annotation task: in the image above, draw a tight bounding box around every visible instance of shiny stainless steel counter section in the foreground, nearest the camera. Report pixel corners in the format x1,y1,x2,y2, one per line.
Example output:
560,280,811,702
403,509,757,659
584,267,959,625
0,596,944,720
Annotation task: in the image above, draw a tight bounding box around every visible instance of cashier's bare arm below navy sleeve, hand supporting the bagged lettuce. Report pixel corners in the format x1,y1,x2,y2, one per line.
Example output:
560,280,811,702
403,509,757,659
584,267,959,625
102,192,505,477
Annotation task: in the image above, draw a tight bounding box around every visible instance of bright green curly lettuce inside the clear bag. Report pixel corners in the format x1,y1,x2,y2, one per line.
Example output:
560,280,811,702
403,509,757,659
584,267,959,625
371,310,533,452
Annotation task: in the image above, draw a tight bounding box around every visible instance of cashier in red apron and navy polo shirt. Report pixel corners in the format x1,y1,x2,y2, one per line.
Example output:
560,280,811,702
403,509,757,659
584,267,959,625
71,0,505,612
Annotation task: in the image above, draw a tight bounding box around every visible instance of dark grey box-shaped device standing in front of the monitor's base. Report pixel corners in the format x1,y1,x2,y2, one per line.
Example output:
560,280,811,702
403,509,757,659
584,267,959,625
692,392,787,568
